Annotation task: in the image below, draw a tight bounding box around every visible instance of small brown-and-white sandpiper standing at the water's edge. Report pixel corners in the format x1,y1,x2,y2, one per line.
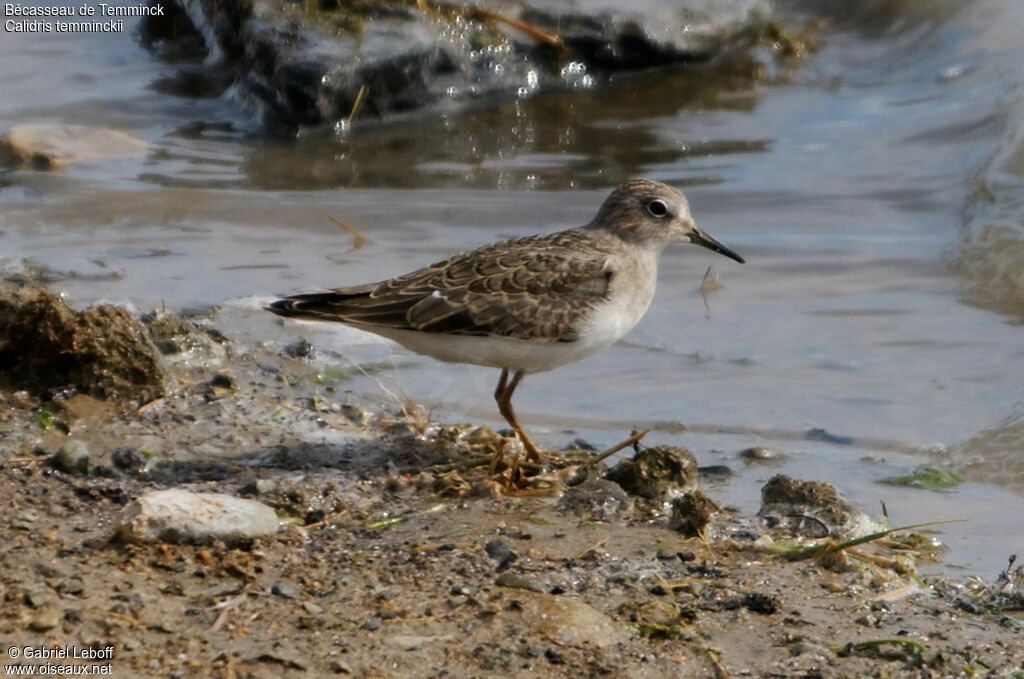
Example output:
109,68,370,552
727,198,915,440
267,179,744,461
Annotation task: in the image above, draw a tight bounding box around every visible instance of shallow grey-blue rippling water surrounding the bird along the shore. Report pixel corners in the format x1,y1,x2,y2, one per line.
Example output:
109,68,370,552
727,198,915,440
0,0,1024,576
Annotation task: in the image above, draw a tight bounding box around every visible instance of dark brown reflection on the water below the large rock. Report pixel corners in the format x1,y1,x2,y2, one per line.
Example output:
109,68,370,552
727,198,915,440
242,58,770,189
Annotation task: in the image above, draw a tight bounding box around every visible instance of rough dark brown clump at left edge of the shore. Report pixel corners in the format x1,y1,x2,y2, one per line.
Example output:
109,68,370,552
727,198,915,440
0,287,164,401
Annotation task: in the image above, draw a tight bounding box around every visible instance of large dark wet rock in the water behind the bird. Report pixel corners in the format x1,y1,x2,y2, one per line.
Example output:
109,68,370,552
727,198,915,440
143,0,770,135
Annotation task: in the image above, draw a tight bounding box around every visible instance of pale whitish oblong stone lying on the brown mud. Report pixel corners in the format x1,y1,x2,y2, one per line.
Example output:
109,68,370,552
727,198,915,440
118,489,278,543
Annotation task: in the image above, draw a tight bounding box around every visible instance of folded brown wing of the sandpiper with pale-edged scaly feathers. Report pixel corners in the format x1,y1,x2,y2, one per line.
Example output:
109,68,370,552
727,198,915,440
269,229,612,341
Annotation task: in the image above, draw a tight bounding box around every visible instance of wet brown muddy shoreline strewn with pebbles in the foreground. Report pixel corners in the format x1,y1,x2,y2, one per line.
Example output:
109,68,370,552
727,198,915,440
0,288,1024,677
